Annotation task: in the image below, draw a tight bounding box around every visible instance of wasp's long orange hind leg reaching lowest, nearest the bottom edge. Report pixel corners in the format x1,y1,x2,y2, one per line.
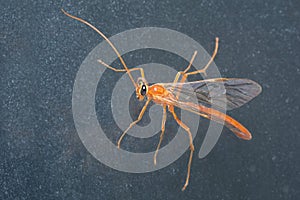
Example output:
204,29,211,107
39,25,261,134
169,106,195,191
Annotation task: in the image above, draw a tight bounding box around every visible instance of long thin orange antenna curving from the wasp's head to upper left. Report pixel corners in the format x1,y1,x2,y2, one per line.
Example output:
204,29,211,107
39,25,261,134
61,9,137,88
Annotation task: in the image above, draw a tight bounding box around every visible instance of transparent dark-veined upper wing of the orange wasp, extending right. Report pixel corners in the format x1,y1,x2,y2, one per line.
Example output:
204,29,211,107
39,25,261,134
161,78,261,110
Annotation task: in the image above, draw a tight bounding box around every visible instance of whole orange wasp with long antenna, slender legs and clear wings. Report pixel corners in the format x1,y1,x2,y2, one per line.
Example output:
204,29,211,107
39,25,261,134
62,9,262,190
